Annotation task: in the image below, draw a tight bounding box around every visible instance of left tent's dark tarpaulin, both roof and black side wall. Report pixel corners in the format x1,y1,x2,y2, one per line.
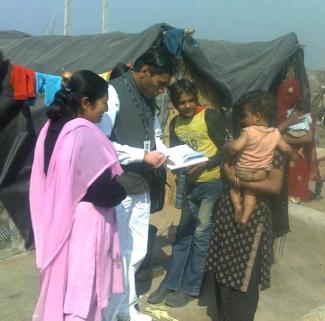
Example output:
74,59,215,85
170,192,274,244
0,24,231,255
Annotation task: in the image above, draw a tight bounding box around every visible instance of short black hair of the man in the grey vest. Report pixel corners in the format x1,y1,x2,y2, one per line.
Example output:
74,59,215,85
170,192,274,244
133,47,177,75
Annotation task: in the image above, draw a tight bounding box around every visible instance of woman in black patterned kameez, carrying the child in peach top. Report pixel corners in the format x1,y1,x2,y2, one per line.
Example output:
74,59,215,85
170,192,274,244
207,91,290,321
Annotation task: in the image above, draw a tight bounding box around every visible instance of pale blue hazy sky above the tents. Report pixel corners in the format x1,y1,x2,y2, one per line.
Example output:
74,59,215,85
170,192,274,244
0,0,325,70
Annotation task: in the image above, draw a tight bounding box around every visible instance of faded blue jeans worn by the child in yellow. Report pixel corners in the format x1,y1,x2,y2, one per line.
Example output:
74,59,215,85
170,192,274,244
161,180,222,297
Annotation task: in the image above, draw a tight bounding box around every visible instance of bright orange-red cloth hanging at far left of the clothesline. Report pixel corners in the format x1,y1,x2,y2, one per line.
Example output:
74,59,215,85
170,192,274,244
10,64,36,100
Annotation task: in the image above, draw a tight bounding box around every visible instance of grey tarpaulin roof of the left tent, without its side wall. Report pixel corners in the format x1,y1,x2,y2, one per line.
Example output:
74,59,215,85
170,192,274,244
0,23,230,105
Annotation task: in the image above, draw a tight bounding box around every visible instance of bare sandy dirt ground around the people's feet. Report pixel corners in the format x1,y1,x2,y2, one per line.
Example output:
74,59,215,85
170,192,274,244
0,199,325,321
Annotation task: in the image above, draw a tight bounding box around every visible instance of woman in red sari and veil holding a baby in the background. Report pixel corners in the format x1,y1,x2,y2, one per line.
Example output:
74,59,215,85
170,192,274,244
277,79,320,203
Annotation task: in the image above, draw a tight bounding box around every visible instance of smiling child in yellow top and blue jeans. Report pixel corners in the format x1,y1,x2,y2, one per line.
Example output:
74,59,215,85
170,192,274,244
148,79,226,307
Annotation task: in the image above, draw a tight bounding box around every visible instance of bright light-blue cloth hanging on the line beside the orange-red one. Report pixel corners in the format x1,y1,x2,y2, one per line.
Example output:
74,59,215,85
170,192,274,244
36,72,62,106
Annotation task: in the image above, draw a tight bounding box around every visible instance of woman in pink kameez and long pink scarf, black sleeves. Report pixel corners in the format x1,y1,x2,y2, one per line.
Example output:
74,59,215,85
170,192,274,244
30,70,126,321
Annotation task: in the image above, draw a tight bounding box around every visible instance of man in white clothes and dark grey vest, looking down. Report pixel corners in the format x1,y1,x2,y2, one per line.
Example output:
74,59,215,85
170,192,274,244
98,49,175,321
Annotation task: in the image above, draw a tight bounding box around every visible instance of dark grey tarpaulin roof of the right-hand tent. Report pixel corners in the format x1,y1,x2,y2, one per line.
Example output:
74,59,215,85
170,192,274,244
200,32,310,103
